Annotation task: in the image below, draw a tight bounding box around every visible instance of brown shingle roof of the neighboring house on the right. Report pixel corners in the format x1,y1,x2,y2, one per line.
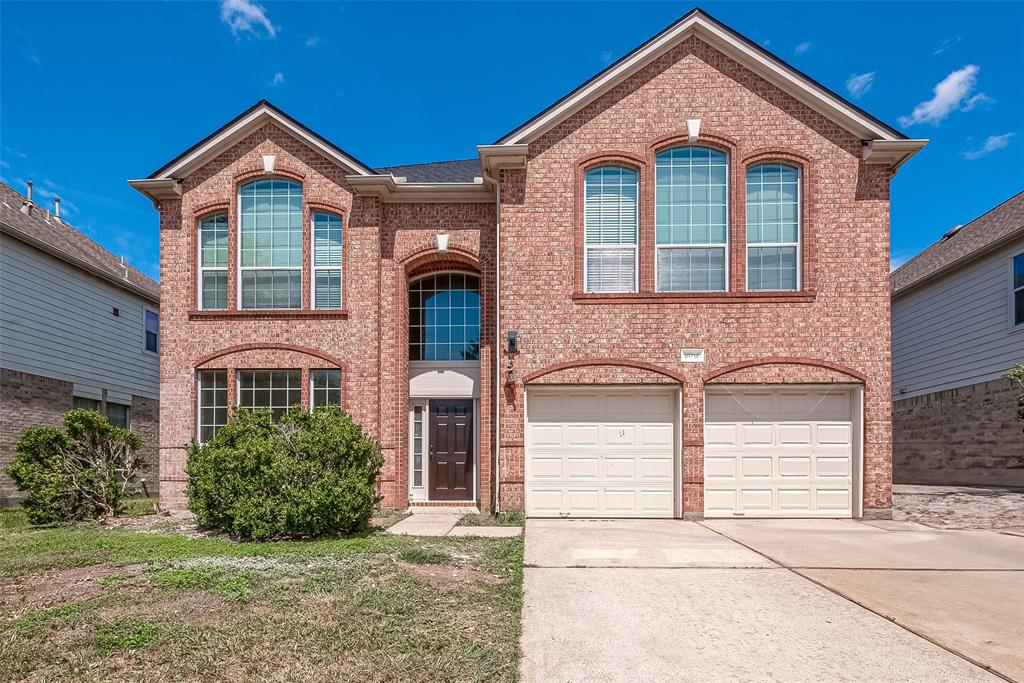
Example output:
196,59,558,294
890,191,1024,295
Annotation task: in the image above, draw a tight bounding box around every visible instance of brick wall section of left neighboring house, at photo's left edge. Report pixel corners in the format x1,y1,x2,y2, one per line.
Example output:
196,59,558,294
0,369,74,507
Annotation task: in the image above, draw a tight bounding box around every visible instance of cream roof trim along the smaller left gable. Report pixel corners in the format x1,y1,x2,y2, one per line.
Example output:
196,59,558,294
151,103,374,179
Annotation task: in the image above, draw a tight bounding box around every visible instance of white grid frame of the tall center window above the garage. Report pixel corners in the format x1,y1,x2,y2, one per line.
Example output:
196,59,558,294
654,145,730,293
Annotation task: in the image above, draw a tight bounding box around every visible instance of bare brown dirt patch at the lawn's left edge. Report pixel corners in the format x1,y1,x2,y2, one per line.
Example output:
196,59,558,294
0,564,141,617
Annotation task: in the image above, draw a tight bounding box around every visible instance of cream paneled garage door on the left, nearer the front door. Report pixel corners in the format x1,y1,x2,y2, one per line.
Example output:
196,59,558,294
525,387,676,517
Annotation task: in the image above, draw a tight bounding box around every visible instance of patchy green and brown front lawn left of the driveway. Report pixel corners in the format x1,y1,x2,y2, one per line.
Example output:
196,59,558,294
0,510,522,681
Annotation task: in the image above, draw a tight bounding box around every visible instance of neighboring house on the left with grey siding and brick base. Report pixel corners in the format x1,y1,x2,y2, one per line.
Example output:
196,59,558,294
0,183,160,506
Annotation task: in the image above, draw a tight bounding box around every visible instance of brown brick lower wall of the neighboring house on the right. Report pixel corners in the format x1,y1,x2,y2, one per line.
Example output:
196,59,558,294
893,379,1024,486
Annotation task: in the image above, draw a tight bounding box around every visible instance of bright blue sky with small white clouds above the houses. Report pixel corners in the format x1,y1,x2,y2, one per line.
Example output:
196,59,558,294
0,0,1024,276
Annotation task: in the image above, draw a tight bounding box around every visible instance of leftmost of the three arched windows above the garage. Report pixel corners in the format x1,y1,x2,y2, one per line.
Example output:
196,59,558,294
583,166,639,292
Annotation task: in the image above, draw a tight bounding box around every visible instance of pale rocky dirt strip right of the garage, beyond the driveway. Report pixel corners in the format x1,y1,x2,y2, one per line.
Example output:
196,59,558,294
893,486,1024,532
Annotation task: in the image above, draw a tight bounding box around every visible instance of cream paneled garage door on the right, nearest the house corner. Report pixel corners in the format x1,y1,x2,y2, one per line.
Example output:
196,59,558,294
705,386,854,517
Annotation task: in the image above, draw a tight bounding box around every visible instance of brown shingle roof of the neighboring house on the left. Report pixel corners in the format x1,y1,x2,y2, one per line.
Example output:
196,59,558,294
0,183,160,301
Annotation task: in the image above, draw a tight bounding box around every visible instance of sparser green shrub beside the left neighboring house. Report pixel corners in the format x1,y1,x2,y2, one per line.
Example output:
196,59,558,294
7,411,142,524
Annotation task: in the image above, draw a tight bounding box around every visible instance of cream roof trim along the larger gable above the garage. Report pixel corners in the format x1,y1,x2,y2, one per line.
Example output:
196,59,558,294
496,9,925,163
